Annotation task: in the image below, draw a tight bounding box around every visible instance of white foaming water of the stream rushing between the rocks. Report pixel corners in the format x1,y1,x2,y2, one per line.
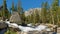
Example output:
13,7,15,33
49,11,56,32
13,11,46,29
6,21,51,32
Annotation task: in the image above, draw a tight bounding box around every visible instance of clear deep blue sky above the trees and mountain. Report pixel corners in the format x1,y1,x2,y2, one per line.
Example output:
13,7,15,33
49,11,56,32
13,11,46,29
0,0,52,10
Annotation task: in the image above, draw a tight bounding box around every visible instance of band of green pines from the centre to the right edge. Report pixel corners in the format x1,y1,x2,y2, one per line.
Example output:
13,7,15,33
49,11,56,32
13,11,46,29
26,0,60,25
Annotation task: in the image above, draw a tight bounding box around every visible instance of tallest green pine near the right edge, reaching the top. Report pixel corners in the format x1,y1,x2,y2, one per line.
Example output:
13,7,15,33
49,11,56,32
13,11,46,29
52,0,59,24
